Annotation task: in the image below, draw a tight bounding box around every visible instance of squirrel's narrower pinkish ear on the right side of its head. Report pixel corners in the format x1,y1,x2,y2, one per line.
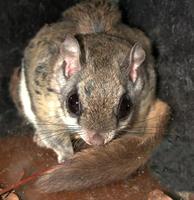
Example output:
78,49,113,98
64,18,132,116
129,42,145,82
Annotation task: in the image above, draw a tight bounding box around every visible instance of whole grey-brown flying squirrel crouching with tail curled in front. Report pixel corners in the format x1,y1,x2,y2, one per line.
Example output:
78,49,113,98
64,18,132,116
11,0,169,192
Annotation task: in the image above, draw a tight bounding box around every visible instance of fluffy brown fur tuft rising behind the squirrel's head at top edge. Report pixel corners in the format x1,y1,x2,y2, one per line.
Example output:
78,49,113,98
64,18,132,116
63,0,121,34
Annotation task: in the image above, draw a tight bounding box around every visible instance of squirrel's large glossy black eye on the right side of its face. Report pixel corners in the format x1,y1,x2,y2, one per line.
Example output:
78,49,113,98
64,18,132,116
117,94,132,120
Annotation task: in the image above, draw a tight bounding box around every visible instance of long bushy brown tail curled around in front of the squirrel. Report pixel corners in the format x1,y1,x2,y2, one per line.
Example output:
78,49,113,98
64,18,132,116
37,100,169,191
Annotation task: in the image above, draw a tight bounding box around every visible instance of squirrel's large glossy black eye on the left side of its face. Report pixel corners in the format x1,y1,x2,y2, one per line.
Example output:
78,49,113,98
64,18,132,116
67,92,81,117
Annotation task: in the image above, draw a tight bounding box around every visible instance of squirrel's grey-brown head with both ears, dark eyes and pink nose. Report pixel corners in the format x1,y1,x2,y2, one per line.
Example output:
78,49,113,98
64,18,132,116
50,34,155,145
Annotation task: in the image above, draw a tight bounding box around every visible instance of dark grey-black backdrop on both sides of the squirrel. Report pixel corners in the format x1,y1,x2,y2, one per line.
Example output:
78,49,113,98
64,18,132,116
0,0,194,191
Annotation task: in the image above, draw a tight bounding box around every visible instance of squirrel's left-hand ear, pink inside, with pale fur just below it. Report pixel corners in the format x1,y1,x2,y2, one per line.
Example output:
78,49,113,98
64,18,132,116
50,35,81,93
